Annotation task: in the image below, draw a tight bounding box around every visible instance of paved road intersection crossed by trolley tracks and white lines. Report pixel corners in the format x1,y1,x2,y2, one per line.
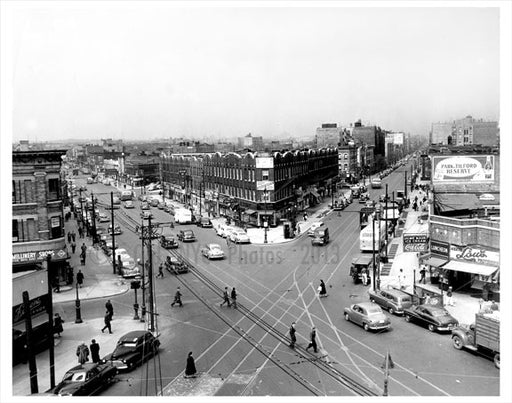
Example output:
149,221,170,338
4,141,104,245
59,167,499,396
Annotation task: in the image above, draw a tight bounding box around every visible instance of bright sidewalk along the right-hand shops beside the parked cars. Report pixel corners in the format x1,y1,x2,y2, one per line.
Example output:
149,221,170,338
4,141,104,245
380,190,480,324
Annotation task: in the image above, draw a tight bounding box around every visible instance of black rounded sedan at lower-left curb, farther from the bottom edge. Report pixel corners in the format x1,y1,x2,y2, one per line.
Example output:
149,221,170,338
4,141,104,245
102,330,160,371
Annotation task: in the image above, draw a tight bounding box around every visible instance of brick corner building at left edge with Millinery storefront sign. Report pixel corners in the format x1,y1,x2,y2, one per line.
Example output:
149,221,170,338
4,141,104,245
12,150,68,281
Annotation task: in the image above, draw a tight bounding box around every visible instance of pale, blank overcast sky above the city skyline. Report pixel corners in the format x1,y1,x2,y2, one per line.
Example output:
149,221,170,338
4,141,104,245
8,2,500,141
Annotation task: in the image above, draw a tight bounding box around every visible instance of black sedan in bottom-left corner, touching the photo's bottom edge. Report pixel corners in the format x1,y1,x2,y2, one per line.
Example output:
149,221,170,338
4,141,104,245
52,363,117,396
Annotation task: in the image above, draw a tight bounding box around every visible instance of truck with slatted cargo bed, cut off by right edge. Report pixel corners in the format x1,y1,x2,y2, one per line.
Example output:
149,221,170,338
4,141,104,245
452,311,500,368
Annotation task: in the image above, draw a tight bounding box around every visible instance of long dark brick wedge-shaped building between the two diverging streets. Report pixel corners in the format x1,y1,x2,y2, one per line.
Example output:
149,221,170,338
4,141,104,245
162,148,338,226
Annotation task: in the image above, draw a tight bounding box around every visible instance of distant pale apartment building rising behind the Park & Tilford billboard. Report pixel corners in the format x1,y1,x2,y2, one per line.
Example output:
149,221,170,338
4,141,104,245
430,116,499,146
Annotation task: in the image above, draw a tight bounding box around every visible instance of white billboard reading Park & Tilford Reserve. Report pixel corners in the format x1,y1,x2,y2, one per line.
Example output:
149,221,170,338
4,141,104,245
432,155,495,184
